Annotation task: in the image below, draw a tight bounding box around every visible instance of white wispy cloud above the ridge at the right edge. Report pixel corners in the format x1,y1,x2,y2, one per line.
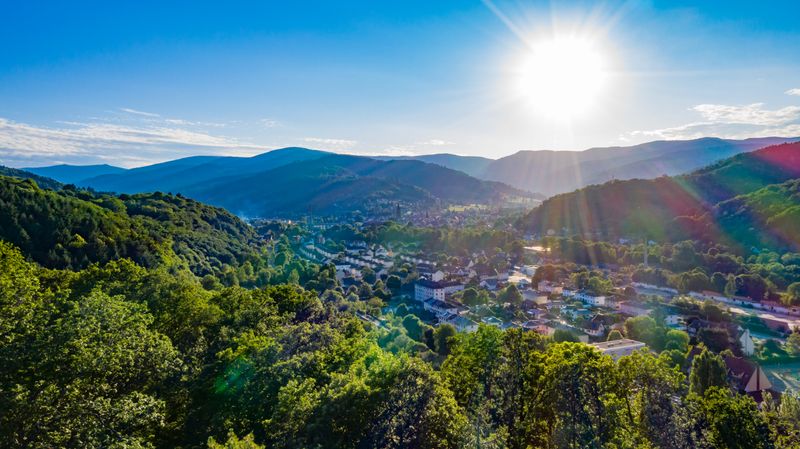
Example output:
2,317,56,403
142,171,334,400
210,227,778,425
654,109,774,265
620,103,800,141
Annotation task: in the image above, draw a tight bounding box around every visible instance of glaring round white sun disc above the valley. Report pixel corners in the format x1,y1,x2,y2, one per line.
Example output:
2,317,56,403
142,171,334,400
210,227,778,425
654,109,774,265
517,37,606,119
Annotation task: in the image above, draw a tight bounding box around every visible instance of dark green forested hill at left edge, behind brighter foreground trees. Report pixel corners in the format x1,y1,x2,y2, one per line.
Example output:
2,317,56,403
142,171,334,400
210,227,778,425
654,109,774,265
0,176,258,275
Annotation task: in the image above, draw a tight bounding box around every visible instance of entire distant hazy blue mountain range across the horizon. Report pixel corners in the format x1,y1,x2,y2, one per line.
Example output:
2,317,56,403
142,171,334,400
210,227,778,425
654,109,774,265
27,137,798,215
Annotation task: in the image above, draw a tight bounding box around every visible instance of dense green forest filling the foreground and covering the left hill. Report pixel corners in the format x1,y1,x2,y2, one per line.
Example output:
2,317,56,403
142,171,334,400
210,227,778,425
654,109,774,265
0,174,800,448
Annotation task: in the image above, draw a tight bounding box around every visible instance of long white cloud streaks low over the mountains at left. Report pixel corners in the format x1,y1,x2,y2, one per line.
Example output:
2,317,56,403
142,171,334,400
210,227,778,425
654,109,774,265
0,118,270,166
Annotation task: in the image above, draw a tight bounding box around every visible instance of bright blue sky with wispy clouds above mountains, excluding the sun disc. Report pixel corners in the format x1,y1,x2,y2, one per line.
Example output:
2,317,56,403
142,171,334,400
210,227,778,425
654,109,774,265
0,0,800,167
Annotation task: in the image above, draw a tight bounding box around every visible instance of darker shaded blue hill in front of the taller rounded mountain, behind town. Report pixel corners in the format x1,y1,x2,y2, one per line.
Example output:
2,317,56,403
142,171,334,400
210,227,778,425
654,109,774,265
186,155,527,215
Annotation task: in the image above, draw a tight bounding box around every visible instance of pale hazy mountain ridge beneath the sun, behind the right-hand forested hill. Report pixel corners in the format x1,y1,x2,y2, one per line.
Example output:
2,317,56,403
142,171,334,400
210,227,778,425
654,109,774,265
384,137,798,195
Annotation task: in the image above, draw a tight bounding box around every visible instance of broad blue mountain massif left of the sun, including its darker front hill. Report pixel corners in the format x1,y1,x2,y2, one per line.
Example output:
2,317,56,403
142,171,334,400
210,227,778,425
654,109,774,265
76,148,534,216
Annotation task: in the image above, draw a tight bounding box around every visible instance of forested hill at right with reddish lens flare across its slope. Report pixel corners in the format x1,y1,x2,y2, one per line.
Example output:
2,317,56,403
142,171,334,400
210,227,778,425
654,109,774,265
518,143,800,250
